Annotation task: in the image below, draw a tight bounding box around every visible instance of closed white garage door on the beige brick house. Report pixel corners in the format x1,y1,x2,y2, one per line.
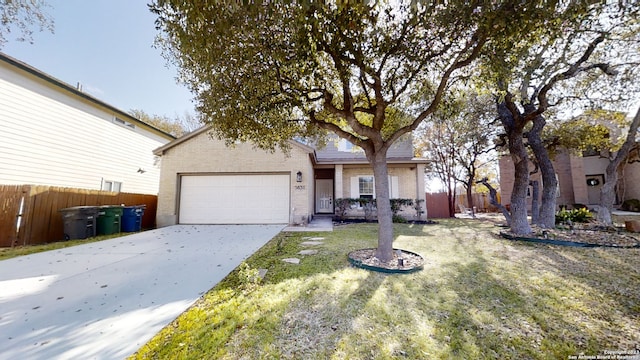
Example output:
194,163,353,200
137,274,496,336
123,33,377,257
179,174,290,224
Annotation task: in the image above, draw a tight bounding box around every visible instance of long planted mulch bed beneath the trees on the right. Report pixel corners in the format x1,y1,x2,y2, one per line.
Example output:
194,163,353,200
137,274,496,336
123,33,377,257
500,224,640,248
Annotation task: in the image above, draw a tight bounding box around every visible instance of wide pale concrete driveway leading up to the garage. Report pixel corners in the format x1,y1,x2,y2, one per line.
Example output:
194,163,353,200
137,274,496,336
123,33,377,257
0,225,284,359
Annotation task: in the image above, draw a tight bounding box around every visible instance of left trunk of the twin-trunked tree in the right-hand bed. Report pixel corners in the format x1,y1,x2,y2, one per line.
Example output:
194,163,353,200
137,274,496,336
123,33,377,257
498,101,531,235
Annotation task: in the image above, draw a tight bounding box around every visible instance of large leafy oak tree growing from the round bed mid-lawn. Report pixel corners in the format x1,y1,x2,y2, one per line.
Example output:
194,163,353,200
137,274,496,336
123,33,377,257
150,0,584,260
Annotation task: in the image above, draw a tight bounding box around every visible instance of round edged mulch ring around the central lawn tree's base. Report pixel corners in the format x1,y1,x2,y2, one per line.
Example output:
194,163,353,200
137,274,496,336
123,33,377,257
348,248,424,274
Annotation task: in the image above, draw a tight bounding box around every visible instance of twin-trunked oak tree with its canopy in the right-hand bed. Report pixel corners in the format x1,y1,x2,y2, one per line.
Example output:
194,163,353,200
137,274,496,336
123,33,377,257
486,2,638,234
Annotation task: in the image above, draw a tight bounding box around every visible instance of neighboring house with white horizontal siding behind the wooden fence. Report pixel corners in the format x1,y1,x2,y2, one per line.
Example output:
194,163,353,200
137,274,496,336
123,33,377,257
0,53,175,194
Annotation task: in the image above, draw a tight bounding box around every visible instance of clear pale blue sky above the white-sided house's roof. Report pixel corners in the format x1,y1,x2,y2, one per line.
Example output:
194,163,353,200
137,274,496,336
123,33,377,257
0,0,195,118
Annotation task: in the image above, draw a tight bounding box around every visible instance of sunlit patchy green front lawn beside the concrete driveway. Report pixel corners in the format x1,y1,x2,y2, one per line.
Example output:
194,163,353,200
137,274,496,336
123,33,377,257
132,219,640,359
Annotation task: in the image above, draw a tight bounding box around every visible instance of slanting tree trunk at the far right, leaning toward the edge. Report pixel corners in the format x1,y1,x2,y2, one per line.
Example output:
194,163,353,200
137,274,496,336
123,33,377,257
597,108,640,226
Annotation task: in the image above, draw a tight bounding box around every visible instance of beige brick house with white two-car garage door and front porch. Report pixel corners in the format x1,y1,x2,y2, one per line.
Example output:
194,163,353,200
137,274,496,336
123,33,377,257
154,127,426,226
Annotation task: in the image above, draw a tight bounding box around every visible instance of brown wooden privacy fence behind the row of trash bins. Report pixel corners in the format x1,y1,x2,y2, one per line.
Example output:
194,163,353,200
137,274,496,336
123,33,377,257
0,185,158,247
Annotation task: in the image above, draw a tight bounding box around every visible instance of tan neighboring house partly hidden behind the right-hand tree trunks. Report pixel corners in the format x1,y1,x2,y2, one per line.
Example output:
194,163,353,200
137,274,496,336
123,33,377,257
499,151,640,209
